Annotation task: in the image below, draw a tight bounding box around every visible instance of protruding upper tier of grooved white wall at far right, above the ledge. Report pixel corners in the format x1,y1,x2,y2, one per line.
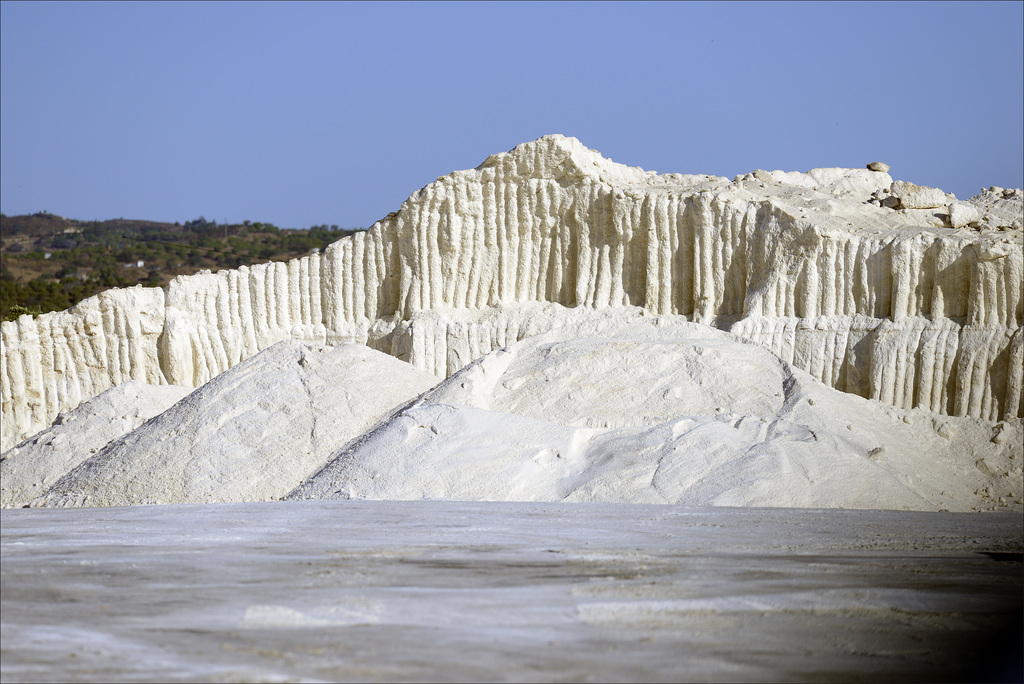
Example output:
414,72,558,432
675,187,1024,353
743,211,1024,329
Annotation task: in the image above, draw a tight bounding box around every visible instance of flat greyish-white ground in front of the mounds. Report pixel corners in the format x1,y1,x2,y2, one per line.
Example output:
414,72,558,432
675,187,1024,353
0,501,1024,682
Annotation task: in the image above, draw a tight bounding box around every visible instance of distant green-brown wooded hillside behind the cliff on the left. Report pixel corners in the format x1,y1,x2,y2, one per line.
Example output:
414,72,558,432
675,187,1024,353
0,212,356,320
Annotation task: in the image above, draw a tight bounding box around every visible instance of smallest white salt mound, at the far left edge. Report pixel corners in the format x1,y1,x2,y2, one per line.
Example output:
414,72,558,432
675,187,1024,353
0,380,194,508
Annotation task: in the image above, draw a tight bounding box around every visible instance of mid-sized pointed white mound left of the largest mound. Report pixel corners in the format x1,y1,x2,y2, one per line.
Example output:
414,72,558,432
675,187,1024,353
32,341,437,506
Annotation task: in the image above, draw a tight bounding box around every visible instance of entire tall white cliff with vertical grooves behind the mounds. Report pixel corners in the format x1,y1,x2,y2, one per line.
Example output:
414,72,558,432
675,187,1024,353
0,135,1024,450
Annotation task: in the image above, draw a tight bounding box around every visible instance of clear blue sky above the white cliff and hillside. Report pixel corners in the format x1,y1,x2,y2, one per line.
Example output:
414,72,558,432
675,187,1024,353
0,0,1024,227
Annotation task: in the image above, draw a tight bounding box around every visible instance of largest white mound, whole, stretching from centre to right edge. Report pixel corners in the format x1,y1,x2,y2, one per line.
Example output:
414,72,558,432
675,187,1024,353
290,316,1024,511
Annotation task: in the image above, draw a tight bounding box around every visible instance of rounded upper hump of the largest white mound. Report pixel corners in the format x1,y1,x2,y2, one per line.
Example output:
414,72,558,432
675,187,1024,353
421,315,790,427
